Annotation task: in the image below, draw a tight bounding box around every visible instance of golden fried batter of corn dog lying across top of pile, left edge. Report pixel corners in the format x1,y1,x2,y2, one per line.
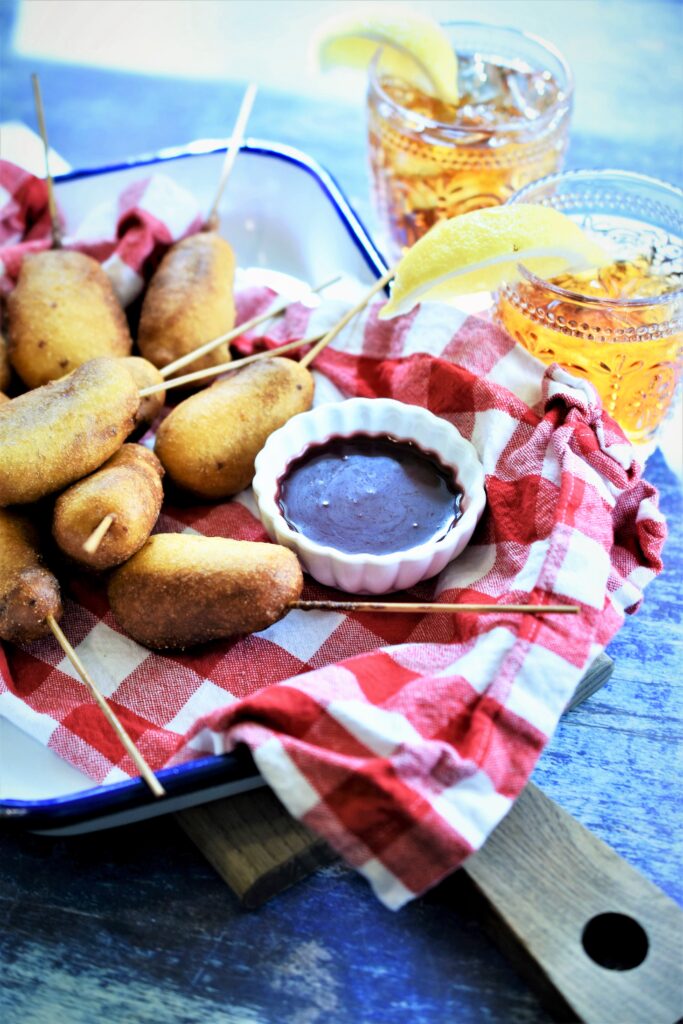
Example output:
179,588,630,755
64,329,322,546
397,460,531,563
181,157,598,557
0,357,139,507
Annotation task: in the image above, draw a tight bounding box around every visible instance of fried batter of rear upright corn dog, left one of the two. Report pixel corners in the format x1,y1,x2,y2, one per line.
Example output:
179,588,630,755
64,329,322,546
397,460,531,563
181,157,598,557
7,250,132,387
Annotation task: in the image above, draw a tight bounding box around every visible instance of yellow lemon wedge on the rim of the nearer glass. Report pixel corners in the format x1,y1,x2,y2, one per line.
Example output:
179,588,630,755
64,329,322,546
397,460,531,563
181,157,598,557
379,203,610,319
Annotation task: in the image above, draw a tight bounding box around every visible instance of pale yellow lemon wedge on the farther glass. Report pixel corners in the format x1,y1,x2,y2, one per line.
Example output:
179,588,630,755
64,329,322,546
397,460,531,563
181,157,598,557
313,7,458,103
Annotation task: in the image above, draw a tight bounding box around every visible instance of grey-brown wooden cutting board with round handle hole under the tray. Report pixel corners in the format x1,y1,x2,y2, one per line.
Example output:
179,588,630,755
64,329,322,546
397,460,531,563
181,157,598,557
176,655,683,1024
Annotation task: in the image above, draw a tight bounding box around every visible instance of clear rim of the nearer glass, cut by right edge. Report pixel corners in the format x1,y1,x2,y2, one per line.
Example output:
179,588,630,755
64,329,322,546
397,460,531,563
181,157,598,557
505,168,683,309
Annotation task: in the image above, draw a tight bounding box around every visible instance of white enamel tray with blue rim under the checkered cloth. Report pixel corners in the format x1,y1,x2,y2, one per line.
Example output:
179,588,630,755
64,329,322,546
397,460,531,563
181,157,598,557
0,139,386,835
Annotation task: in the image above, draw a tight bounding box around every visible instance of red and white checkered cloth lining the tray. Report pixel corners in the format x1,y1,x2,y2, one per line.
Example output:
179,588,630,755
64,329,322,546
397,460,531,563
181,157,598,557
0,163,666,908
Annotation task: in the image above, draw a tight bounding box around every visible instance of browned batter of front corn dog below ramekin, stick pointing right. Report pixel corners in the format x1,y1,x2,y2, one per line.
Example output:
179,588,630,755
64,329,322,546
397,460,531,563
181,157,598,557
109,534,303,649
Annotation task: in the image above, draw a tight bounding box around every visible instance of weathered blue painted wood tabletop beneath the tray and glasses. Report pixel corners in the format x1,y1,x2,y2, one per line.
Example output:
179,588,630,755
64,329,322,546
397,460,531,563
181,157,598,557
0,0,683,1024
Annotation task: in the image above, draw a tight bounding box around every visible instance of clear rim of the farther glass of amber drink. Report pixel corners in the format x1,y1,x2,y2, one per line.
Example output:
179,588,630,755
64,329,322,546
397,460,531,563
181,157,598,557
369,22,574,136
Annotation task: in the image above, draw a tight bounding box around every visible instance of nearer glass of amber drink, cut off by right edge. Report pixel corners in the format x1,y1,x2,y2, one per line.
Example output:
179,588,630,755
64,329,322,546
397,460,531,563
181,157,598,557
496,171,683,446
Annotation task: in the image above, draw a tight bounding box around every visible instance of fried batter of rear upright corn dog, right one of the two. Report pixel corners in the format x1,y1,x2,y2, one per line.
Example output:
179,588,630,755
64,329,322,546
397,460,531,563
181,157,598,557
137,231,234,374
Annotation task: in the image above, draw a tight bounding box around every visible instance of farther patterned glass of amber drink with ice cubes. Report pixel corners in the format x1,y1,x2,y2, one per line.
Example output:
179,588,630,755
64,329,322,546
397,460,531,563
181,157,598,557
368,23,572,259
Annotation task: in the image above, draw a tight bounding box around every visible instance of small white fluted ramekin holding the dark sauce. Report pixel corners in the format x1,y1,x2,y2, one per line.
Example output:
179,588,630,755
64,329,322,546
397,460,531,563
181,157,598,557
253,398,486,594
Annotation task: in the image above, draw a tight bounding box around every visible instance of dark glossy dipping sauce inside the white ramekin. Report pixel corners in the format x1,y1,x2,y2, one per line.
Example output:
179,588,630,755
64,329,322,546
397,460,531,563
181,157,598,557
278,434,463,555
